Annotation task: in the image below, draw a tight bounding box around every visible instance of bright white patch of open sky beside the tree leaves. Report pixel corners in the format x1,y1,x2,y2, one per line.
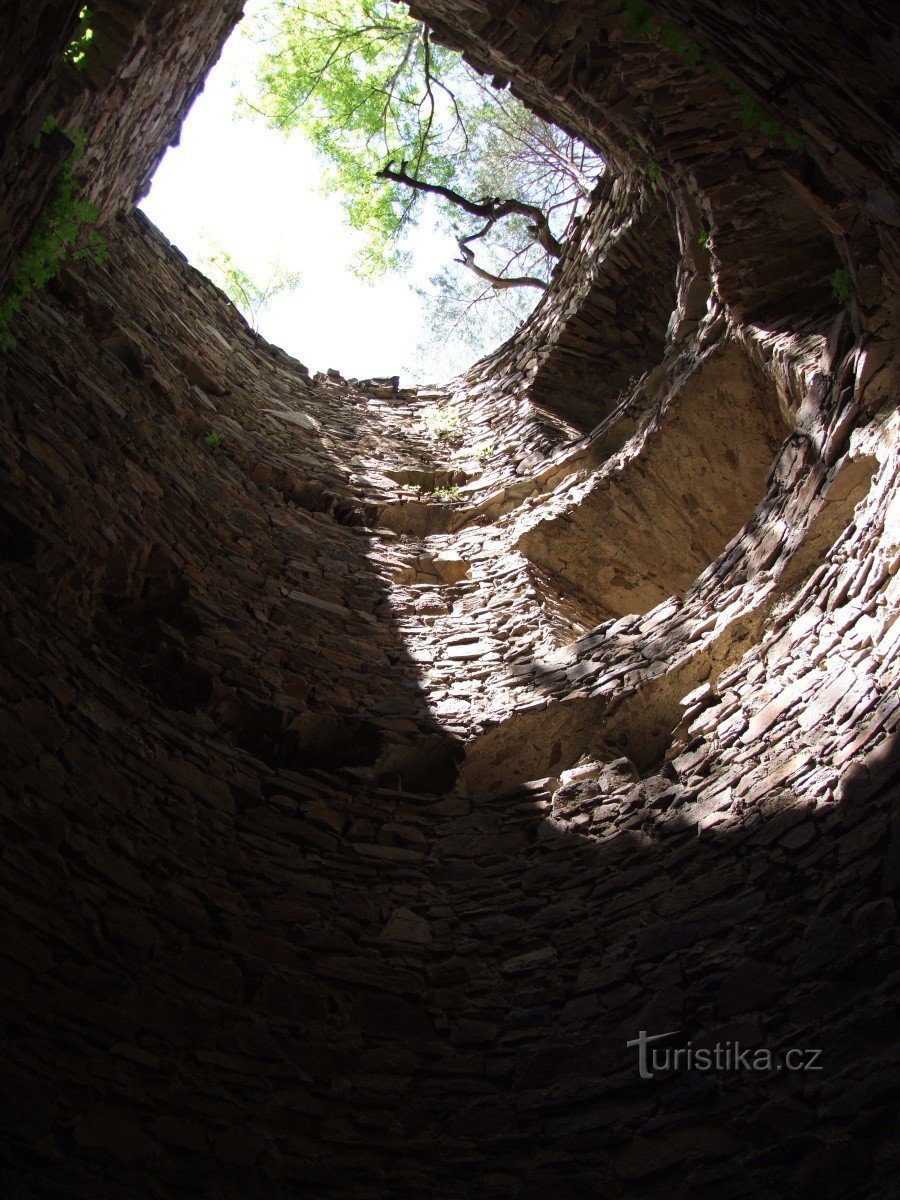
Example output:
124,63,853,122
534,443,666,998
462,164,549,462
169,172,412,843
140,0,472,383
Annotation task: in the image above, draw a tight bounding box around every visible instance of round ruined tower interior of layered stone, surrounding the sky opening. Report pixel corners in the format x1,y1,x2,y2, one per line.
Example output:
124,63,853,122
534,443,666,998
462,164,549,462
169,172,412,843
0,0,900,1200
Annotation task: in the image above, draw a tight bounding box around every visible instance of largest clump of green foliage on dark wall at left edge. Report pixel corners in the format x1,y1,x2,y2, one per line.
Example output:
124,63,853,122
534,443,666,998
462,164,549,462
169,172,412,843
0,127,109,350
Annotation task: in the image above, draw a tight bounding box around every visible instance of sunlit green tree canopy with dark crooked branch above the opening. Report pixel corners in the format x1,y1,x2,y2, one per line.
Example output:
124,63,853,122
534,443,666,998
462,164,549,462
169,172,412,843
241,0,604,348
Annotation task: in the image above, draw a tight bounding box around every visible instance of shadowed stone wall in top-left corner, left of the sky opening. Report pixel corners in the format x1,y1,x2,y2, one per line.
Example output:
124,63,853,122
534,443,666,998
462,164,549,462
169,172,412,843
0,0,244,297
